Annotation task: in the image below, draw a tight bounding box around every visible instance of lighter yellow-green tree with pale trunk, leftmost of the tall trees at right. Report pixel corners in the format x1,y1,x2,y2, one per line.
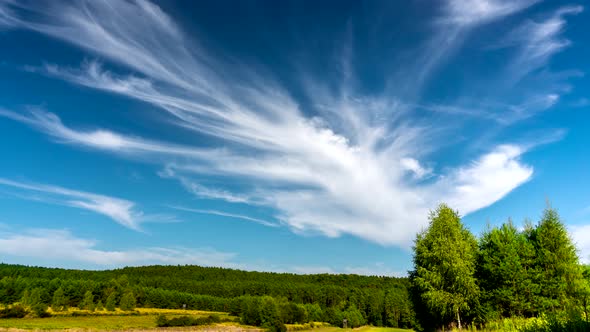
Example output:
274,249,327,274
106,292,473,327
410,204,479,328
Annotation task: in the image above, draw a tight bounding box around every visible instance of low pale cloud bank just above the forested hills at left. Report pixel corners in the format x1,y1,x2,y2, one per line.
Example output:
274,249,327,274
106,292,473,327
0,229,236,268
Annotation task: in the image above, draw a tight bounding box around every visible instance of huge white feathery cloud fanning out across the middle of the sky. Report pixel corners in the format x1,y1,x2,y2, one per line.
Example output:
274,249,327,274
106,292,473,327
0,1,544,247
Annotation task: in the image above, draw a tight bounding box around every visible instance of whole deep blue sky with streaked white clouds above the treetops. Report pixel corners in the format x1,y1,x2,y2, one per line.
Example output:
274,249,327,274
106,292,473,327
0,0,590,276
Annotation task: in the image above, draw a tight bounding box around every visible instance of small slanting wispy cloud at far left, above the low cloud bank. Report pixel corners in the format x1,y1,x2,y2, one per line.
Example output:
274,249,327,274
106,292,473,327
0,178,151,230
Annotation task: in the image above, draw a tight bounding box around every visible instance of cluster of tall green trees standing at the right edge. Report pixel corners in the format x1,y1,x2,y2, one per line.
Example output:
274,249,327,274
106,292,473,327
410,204,590,330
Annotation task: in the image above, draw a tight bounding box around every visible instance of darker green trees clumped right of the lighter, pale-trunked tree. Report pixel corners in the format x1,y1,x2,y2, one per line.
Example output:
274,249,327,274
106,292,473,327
477,208,589,320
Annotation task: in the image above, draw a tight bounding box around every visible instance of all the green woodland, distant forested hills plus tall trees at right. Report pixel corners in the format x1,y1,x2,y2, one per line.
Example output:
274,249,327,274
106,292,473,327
0,204,590,331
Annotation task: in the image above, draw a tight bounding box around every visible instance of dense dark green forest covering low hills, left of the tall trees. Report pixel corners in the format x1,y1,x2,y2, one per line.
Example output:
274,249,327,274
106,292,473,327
0,264,413,327
